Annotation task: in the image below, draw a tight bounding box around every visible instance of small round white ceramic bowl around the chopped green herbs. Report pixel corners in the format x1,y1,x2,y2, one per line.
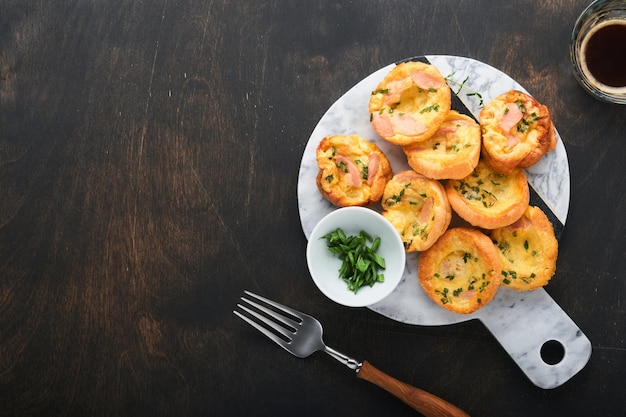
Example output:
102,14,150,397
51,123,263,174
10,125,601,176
306,207,406,307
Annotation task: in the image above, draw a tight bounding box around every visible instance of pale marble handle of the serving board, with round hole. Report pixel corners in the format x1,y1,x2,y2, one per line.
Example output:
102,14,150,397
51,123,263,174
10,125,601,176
479,288,591,389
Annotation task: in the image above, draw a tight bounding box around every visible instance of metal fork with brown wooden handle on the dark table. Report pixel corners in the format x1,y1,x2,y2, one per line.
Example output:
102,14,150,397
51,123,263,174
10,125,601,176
233,291,469,417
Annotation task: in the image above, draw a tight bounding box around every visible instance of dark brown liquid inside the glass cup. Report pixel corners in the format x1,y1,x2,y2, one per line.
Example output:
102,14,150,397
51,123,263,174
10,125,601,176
585,21,626,87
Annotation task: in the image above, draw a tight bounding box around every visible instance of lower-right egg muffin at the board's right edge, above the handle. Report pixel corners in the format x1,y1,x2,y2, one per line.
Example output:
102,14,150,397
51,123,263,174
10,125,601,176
490,206,559,291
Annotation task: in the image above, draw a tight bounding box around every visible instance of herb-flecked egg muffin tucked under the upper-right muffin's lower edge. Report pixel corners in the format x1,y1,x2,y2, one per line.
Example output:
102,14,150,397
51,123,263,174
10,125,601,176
446,160,530,229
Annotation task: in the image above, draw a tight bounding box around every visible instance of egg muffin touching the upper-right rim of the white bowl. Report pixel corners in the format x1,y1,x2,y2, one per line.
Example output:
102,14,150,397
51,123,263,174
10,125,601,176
381,170,452,252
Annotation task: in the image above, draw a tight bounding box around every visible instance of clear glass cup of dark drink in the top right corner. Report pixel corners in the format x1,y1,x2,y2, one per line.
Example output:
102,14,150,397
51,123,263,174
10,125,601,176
570,0,626,104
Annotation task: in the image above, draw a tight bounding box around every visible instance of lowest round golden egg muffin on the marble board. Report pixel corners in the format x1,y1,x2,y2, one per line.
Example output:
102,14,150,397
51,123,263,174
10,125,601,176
417,227,502,314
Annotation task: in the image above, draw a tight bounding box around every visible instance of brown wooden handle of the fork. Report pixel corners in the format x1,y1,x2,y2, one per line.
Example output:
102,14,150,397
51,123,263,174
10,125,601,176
356,361,469,417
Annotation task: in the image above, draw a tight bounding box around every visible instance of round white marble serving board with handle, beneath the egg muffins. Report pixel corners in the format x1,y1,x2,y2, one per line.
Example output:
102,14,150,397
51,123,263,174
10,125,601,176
298,55,591,389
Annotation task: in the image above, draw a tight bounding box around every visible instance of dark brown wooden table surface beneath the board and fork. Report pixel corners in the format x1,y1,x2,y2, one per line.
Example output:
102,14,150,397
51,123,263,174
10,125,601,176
0,0,626,417
